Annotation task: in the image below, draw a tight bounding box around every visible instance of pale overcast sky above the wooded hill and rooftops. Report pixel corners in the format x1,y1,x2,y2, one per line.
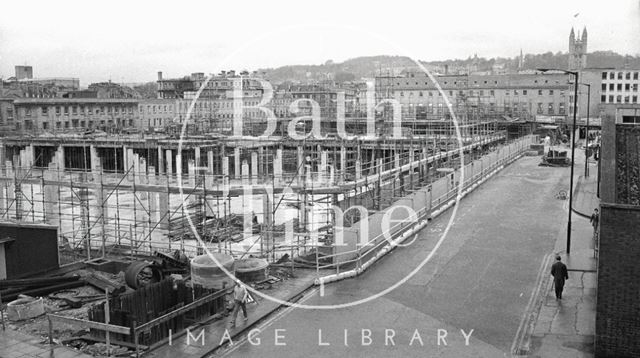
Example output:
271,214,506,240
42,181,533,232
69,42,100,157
0,0,640,86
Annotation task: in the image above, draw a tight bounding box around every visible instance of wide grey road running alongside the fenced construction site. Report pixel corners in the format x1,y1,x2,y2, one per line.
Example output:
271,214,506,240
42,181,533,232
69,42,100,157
216,157,569,358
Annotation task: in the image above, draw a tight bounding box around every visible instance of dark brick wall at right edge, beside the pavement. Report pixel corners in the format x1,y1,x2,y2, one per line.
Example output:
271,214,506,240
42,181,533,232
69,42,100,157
595,203,640,358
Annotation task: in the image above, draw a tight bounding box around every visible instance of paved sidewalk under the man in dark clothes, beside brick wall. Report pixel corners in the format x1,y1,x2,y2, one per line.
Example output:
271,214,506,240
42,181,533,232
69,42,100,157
518,161,599,358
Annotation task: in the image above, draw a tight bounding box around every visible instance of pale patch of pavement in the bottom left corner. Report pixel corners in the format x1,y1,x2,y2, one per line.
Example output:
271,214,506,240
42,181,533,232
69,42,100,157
0,329,91,358
